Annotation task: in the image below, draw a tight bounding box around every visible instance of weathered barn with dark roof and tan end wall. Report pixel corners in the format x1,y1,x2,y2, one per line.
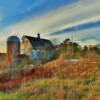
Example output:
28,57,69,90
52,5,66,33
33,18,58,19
22,34,53,60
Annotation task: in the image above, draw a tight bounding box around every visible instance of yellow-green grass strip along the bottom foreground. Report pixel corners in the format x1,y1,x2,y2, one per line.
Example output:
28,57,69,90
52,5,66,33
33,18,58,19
0,73,100,100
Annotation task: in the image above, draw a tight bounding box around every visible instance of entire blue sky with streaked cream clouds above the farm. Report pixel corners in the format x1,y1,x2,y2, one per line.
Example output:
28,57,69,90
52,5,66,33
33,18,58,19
0,0,100,52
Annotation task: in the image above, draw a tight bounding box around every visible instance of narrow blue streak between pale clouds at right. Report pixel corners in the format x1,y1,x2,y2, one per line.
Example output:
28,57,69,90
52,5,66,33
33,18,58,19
50,17,100,35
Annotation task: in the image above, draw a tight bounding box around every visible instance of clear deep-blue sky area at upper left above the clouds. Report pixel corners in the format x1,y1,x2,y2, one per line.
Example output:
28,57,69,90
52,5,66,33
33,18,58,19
0,0,77,28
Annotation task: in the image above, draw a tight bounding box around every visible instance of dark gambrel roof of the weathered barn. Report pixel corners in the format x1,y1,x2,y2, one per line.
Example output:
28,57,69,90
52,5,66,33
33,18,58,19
22,36,53,49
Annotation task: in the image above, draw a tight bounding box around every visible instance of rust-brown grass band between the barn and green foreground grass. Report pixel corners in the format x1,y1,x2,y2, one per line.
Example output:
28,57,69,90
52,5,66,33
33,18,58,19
0,54,100,91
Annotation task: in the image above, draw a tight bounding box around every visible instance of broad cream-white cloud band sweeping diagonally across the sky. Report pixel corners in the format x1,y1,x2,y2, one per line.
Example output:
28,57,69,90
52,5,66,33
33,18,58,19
0,0,100,52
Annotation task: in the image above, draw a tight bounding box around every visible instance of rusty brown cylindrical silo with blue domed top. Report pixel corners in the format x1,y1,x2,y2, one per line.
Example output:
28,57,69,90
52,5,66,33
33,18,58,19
6,36,20,64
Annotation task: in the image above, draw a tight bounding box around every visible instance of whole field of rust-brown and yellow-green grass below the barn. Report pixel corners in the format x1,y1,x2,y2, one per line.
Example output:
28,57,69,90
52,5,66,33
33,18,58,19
0,57,100,100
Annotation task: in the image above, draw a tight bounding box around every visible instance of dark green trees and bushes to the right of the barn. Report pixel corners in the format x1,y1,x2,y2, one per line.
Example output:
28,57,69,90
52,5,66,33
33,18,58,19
55,39,100,59
